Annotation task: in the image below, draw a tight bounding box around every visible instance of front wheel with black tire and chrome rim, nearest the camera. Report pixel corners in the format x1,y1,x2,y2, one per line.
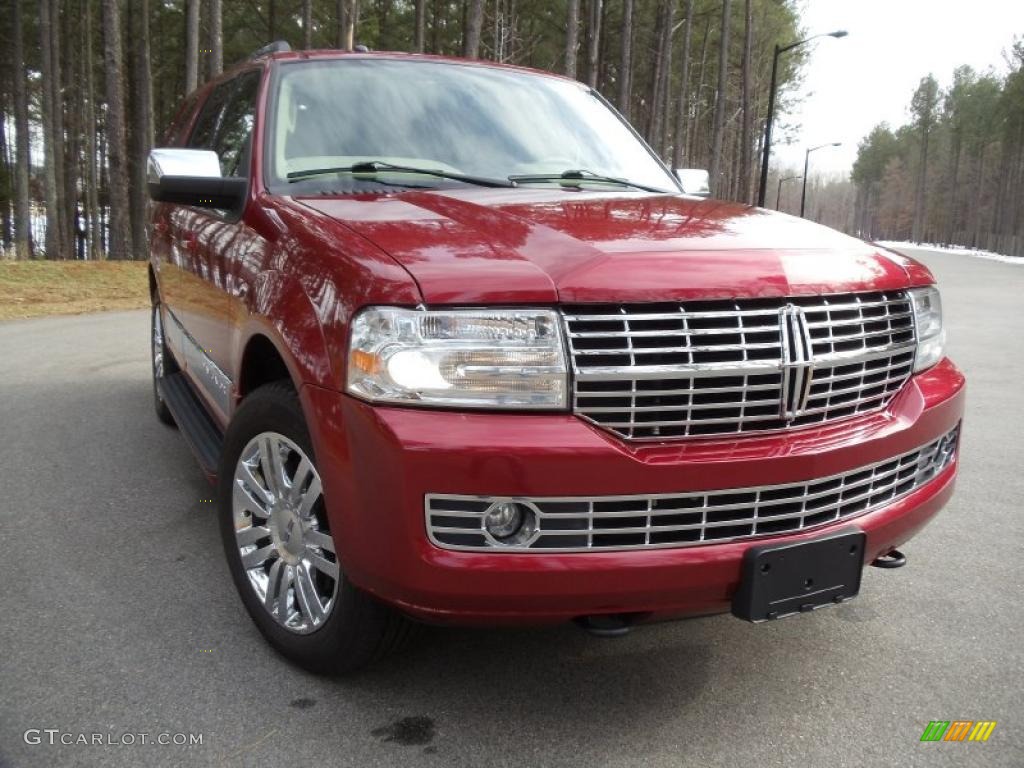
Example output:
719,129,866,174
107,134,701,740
217,383,409,674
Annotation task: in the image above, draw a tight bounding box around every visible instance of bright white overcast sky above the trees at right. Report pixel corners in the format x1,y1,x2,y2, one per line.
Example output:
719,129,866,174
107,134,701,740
772,0,1024,173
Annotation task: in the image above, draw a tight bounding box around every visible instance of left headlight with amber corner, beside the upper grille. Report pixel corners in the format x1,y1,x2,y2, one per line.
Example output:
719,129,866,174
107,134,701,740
347,307,568,409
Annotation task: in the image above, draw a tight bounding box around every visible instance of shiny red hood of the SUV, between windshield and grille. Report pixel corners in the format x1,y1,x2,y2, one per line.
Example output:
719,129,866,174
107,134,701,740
299,188,931,304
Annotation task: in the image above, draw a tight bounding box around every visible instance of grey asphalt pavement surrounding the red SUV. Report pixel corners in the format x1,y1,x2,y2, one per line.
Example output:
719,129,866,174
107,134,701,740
0,246,1024,768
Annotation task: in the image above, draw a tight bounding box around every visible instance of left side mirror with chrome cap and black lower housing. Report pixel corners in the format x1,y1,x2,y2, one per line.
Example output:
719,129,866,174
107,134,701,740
146,147,249,211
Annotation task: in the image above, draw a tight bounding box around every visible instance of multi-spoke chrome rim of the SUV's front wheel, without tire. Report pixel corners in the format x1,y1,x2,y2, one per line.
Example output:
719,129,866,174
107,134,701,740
231,432,340,634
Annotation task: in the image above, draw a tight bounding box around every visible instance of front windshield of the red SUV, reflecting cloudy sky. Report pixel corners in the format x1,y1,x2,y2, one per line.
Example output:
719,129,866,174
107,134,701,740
268,58,677,193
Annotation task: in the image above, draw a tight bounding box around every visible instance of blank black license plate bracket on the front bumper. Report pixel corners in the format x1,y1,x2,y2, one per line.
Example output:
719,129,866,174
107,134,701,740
732,528,866,623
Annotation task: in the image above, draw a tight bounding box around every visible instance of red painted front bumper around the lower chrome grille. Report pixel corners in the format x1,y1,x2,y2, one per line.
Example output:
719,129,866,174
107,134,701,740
302,360,965,624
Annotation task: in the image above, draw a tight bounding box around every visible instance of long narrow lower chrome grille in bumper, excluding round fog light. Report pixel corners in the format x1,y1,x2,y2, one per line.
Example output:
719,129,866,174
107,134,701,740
425,426,959,552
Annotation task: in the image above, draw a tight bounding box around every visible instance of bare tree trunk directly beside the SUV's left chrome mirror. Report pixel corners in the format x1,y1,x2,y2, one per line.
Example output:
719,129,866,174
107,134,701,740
130,0,153,259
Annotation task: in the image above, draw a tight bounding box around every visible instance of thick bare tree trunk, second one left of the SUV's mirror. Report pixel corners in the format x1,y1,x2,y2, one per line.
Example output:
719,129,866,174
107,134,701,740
102,0,131,259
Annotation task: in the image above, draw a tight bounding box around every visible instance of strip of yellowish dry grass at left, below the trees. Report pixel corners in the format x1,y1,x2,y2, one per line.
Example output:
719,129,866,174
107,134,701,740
0,261,150,319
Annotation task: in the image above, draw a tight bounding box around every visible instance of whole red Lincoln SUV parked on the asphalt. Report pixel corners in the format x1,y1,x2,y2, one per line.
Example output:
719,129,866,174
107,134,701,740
150,46,965,671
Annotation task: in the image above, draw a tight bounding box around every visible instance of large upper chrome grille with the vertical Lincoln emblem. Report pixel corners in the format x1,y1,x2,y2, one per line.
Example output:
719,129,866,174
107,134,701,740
564,291,914,440
